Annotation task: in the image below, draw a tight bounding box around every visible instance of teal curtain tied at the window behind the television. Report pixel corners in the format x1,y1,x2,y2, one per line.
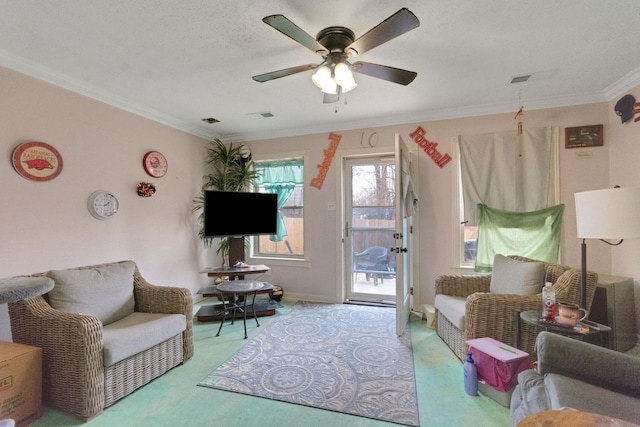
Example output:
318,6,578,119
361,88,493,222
256,159,304,242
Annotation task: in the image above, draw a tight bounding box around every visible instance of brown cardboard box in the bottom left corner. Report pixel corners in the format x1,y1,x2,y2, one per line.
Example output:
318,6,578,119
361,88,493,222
0,341,42,426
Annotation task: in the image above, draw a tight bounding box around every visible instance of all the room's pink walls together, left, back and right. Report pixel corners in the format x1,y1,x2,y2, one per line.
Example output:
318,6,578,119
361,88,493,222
0,63,640,339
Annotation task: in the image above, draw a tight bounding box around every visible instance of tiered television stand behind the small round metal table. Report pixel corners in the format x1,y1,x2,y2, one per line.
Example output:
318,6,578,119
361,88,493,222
196,264,276,322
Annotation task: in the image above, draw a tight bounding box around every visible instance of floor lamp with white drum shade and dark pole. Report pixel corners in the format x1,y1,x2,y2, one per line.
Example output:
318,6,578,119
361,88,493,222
575,187,640,308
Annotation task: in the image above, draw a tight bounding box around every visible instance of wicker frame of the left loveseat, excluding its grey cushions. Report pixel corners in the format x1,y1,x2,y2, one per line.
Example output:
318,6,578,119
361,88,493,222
9,261,193,421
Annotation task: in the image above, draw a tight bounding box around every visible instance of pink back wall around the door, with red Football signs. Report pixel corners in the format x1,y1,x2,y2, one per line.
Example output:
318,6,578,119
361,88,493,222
247,103,610,304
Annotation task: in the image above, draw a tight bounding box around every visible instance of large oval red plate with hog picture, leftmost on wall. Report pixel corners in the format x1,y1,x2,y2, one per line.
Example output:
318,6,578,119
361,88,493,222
12,141,62,181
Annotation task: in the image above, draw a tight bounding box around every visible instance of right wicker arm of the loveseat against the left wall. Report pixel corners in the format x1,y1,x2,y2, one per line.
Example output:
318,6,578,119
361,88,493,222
133,267,193,361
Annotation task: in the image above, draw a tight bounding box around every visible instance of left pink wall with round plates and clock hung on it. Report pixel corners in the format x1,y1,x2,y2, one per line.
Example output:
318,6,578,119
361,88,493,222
0,68,212,340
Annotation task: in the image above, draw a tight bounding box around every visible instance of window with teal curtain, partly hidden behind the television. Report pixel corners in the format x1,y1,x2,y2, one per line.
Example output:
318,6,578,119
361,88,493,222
251,157,305,259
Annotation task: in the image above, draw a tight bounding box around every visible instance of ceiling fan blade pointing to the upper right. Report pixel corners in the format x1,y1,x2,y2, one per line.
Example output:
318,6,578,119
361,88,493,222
344,7,420,56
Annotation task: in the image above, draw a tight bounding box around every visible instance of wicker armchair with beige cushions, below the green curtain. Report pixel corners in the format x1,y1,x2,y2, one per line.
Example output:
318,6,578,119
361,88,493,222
434,256,598,360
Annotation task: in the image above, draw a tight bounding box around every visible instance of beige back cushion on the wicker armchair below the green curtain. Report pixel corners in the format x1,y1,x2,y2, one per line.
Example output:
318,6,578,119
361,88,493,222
489,255,546,295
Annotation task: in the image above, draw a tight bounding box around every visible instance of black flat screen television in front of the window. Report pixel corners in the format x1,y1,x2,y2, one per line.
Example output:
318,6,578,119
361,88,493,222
204,190,278,237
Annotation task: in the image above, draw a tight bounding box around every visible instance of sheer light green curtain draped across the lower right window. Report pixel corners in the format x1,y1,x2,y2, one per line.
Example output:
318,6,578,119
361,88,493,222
475,204,564,271
